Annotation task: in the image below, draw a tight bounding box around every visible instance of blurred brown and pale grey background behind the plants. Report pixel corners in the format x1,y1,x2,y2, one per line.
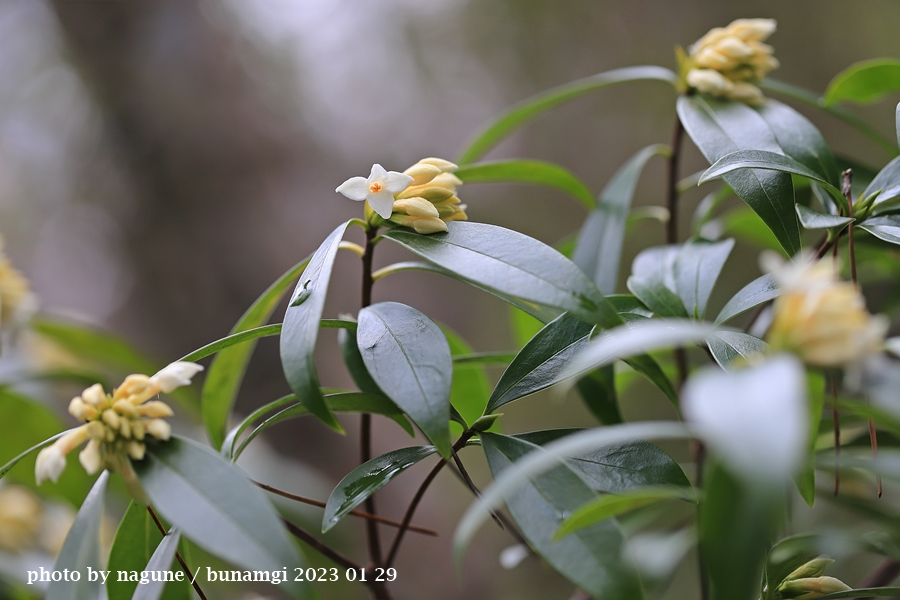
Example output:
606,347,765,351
0,0,900,600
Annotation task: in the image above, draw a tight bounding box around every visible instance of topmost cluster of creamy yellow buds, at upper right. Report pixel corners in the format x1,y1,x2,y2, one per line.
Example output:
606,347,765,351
682,19,778,104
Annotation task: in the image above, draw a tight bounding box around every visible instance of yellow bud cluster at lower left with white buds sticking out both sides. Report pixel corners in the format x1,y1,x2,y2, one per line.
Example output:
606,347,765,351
34,362,203,484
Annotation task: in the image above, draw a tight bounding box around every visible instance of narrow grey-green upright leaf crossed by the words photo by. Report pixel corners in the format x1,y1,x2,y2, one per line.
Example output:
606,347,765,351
44,471,109,600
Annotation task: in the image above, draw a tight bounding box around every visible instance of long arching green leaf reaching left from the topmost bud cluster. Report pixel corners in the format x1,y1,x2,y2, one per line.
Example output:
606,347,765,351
456,66,677,164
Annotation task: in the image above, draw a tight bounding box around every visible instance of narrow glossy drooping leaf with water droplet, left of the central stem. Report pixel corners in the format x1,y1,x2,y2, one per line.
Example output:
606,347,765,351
282,221,350,432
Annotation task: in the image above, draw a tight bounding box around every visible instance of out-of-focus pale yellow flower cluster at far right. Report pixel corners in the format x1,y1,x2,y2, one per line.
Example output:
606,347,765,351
760,253,889,367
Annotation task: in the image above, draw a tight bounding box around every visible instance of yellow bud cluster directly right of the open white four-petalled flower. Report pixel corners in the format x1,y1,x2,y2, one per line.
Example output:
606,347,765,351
388,158,468,233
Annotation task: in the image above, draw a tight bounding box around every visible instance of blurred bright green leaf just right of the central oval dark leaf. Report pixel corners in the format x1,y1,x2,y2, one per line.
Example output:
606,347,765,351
441,325,488,425
